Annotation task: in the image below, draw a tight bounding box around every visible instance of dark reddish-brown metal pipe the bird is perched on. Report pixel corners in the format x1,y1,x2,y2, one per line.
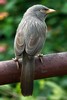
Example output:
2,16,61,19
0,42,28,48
0,52,67,85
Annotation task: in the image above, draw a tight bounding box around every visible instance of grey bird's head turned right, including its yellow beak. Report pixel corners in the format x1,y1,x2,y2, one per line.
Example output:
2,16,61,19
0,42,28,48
24,5,55,20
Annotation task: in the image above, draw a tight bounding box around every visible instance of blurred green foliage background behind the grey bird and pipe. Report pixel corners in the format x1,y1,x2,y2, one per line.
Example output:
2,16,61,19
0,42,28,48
0,0,67,100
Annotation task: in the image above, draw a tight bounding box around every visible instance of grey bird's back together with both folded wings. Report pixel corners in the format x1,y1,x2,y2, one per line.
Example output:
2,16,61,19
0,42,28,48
15,16,46,55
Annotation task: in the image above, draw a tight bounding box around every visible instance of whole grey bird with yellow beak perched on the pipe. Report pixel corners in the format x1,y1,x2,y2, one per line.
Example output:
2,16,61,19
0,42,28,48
14,4,55,96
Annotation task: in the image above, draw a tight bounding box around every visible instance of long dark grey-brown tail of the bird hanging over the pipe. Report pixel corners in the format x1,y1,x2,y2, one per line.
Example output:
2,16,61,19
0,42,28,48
20,52,35,96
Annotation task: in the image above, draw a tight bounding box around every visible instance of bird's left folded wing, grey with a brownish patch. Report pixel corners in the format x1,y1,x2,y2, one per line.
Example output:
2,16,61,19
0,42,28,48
14,21,25,57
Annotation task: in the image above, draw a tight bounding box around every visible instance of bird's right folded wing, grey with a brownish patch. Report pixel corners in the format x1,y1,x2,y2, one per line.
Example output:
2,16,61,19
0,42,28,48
25,19,46,55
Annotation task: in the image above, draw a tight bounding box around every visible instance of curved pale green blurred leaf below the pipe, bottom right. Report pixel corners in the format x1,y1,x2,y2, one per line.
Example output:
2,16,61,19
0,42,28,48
46,81,66,100
